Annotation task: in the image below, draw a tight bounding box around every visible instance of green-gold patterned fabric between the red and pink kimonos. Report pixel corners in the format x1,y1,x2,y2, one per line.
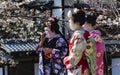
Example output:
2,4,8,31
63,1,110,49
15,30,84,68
85,34,96,75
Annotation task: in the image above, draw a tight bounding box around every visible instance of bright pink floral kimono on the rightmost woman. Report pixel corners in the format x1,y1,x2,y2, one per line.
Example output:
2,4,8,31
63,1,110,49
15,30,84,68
90,30,105,75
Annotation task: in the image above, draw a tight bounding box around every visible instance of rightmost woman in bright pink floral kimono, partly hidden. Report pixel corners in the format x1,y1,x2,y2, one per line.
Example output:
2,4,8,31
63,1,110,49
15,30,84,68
83,12,105,75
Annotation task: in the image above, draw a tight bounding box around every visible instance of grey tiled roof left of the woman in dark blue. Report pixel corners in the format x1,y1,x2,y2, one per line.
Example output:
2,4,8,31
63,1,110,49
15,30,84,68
1,40,38,52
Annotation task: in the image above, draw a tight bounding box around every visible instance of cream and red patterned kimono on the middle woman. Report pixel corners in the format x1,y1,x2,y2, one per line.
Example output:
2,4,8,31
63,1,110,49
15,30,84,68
64,29,92,75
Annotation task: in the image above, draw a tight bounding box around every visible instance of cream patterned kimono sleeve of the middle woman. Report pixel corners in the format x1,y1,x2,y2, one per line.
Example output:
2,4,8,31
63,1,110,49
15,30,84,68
64,33,86,68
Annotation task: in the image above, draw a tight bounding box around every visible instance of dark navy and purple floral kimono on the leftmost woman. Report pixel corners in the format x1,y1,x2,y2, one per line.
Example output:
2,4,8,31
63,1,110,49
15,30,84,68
39,34,68,75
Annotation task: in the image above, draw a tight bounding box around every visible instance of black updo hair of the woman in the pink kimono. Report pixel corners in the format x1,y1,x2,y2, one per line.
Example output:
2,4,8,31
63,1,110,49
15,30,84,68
86,12,97,26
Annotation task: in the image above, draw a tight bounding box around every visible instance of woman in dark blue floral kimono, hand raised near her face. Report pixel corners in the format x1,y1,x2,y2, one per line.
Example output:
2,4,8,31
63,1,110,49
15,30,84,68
36,17,68,75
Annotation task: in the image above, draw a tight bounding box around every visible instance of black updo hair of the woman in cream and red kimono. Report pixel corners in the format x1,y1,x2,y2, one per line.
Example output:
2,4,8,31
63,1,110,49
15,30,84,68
72,9,85,25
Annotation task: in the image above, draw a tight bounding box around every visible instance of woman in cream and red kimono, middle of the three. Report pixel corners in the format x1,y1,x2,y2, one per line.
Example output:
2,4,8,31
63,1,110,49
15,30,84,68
64,8,91,75
